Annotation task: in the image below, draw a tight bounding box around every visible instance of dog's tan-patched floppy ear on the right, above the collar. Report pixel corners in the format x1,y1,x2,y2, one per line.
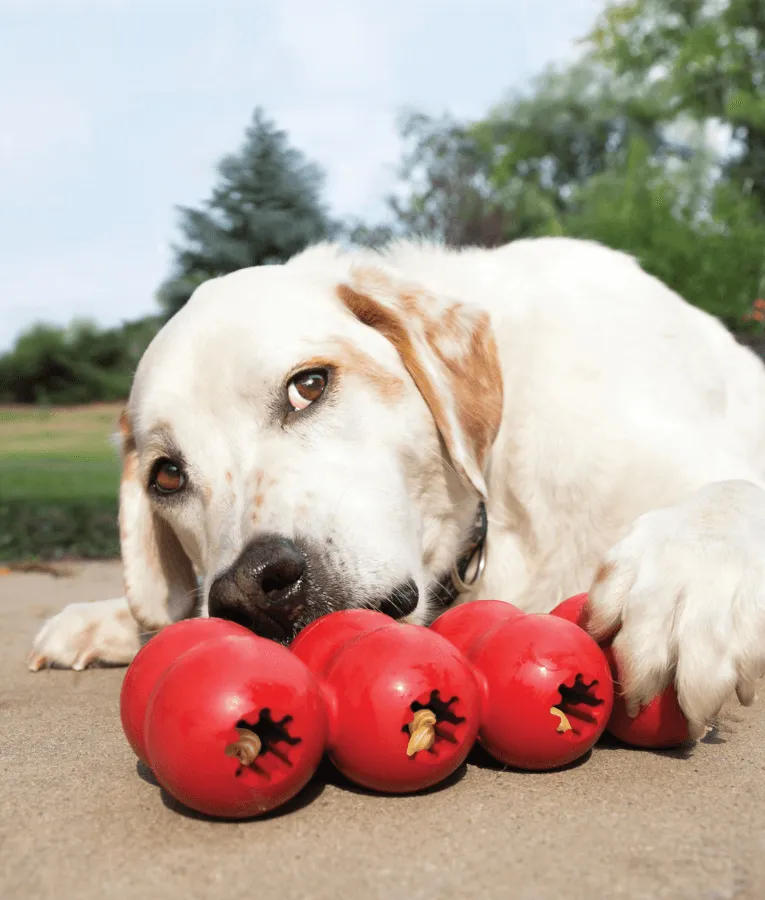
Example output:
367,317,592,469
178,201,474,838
337,267,502,499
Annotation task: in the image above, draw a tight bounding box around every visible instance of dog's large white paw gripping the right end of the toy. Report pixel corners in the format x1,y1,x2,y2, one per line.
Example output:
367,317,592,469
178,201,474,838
589,481,765,738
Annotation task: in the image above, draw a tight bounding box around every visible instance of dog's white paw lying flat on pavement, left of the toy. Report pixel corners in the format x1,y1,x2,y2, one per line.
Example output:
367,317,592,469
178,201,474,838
28,598,140,672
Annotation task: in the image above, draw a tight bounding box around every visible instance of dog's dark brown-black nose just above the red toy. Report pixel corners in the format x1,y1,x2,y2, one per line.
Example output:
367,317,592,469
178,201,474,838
209,535,306,641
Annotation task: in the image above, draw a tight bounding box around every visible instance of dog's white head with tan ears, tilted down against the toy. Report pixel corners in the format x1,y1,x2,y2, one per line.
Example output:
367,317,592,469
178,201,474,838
120,248,502,641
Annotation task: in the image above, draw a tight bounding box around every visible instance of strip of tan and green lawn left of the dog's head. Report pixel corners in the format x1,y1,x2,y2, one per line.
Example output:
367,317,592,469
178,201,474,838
0,405,119,561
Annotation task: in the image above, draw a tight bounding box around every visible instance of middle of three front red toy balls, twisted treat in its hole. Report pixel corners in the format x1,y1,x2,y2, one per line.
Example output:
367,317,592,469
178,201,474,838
302,613,480,793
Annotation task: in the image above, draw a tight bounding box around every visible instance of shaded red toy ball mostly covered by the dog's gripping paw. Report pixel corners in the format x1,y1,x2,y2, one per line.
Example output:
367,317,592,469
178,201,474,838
605,645,690,750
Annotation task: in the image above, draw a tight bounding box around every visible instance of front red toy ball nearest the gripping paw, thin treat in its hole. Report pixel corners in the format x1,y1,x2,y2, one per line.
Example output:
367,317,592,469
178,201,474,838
470,615,614,770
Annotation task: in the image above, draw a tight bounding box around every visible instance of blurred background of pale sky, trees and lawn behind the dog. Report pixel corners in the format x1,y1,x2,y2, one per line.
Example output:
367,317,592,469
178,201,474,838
0,0,765,562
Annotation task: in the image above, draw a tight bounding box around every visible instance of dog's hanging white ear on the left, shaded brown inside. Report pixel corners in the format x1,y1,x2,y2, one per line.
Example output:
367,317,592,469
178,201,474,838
119,412,197,631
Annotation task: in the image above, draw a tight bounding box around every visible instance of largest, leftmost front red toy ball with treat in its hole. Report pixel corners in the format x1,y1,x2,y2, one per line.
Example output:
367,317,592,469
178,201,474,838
145,633,327,818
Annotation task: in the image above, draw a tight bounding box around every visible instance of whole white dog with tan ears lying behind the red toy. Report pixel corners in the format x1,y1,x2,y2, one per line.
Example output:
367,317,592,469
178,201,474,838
30,238,765,736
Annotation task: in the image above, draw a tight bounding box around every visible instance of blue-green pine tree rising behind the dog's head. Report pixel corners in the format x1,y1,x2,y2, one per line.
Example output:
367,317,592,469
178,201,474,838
159,108,336,316
